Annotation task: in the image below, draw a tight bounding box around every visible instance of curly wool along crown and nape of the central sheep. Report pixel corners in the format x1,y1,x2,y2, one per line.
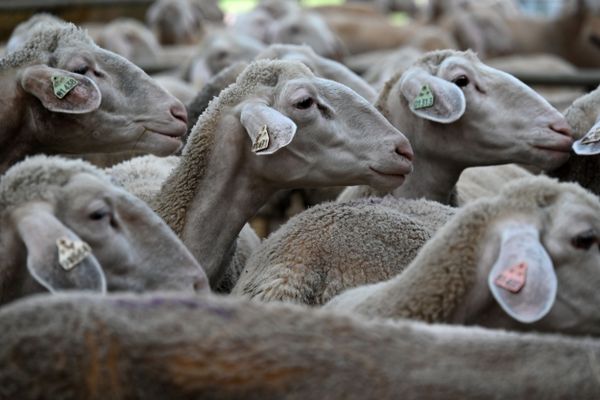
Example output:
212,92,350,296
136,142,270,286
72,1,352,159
154,61,313,236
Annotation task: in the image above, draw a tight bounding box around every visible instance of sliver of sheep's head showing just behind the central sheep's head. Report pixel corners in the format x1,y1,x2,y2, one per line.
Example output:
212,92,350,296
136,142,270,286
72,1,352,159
255,44,377,103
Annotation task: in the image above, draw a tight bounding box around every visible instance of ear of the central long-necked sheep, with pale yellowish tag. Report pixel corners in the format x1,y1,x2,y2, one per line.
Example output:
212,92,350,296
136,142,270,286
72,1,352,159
240,102,296,155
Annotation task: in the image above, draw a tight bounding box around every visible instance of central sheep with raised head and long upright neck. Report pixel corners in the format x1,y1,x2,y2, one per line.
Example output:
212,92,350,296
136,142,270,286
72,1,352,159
110,60,412,287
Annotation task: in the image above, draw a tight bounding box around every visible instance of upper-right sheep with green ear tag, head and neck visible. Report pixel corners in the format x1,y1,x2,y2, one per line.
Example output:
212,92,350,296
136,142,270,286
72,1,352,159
339,50,572,204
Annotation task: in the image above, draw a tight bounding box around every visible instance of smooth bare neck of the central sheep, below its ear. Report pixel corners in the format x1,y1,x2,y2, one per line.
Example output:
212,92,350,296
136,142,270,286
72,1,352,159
158,114,275,286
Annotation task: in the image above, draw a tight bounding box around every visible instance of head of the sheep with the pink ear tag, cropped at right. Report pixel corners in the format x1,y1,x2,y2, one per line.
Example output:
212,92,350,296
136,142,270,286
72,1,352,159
467,190,600,335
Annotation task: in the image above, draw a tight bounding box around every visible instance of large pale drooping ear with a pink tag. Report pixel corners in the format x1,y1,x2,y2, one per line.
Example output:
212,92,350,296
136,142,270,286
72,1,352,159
488,224,557,323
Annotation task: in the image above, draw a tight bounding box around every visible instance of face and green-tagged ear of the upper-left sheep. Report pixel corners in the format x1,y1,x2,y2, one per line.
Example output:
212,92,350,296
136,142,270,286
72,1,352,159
19,38,187,156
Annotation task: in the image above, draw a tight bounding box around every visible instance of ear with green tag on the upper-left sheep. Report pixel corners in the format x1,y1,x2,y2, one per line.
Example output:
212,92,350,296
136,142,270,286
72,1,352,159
21,65,102,114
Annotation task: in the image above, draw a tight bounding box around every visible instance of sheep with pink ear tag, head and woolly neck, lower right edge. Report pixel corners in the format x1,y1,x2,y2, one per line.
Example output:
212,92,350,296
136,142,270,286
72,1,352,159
325,177,600,335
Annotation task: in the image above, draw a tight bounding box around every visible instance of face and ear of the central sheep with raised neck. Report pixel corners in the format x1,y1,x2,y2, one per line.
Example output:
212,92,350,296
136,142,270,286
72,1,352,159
240,77,412,188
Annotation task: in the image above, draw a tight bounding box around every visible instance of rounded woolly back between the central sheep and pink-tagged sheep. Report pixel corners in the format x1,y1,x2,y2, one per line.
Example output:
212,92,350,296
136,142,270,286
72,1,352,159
232,196,455,305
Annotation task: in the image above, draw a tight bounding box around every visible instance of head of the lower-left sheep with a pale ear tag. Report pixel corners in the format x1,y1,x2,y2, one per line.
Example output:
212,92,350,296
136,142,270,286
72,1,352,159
0,169,207,301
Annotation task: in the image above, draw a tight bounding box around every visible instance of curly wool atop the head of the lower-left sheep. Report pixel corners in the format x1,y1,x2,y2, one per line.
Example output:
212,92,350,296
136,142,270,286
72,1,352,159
0,155,111,210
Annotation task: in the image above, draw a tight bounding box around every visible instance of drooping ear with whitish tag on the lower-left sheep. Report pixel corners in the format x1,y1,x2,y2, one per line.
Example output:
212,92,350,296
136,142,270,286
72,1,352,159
13,203,106,293
